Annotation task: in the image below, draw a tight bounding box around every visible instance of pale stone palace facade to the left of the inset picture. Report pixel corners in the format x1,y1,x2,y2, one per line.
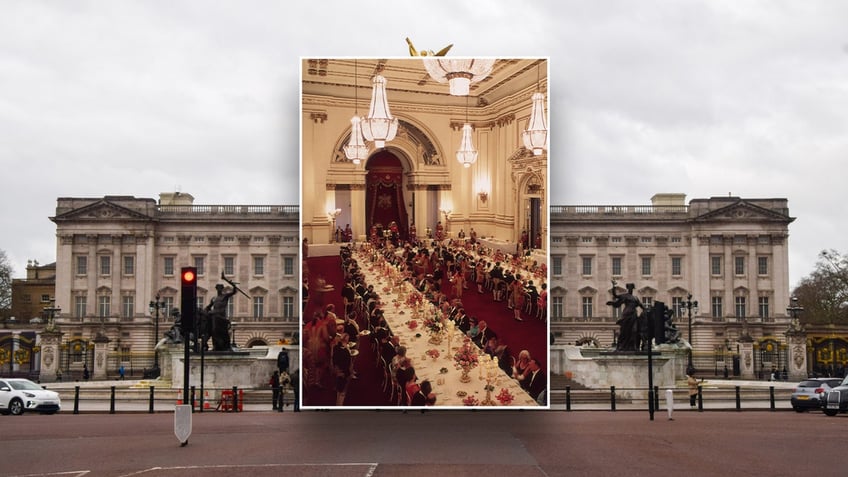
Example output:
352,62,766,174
42,193,300,380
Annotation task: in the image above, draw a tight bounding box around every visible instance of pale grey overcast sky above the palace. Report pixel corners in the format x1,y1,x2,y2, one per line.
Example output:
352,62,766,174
0,0,848,285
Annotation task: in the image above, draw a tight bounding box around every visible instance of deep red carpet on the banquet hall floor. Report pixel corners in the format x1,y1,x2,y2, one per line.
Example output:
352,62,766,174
303,256,549,407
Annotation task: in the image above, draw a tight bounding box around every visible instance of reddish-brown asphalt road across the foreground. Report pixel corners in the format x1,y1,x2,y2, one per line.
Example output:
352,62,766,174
0,410,848,477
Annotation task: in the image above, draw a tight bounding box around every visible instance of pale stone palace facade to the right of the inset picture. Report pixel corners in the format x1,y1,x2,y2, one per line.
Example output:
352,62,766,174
550,194,806,377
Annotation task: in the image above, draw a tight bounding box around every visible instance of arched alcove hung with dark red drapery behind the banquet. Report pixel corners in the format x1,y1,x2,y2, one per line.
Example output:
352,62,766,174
365,150,409,239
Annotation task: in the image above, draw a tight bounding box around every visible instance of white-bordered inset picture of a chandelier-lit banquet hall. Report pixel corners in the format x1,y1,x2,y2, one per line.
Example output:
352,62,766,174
301,56,549,408
